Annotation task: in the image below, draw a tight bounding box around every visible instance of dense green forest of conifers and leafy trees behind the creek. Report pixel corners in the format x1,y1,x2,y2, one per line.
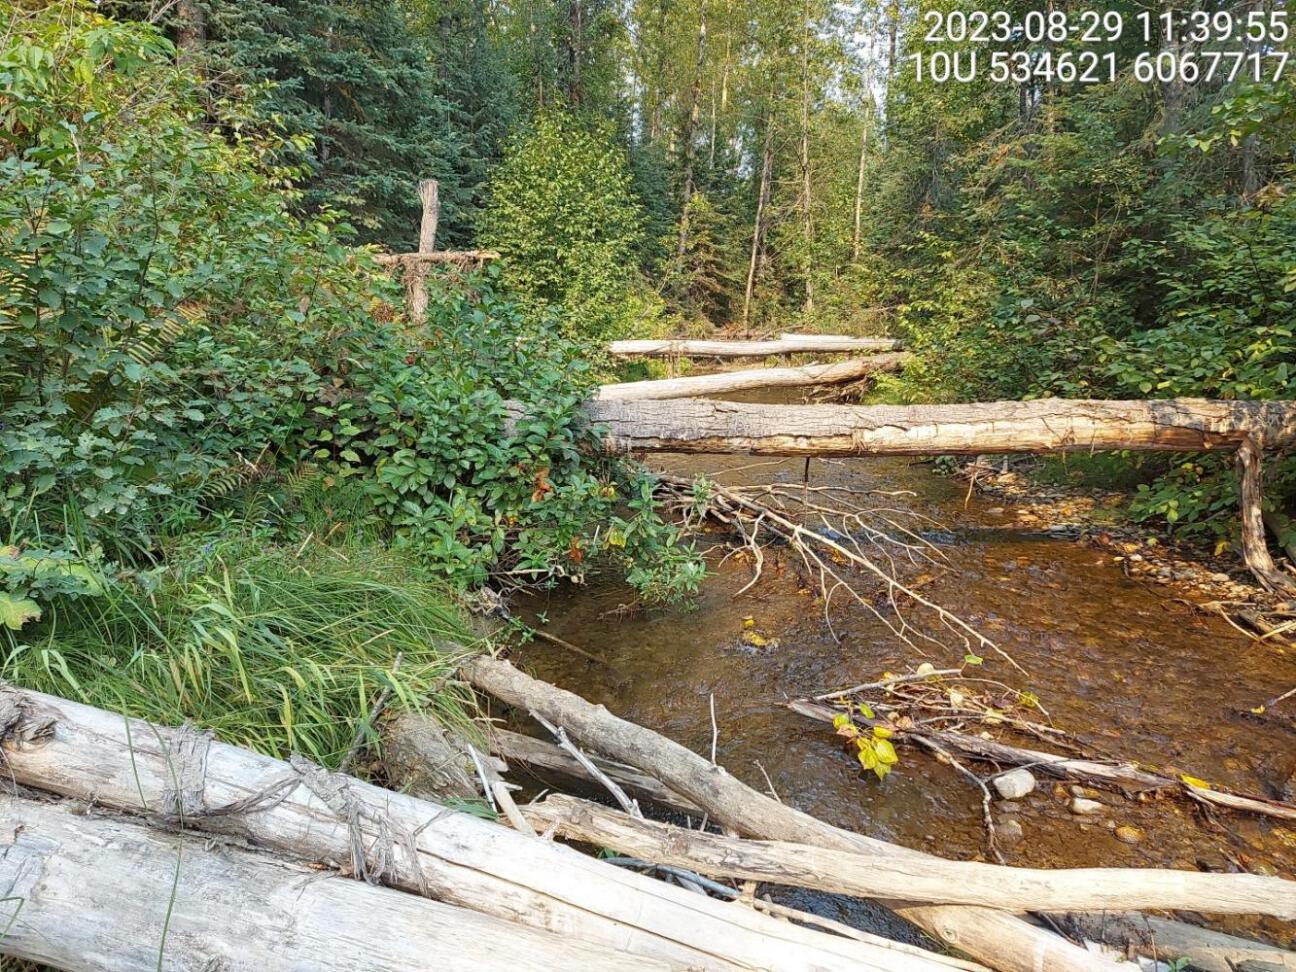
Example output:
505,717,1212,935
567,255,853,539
102,0,1296,542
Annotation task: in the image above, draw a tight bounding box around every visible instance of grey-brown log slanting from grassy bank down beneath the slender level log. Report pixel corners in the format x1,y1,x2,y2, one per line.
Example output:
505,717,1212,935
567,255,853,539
460,657,1118,972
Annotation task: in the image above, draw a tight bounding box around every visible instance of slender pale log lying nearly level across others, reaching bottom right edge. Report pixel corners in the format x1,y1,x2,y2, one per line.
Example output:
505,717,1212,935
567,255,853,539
522,794,1296,920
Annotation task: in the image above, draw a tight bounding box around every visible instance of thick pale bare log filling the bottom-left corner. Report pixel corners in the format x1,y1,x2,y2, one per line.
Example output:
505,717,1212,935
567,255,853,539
0,793,675,972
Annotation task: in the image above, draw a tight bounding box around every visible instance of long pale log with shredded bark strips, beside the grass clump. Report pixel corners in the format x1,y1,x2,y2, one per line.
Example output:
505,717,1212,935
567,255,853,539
0,686,953,972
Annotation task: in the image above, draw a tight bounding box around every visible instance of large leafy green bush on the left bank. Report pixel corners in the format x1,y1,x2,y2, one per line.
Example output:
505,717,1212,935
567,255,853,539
0,8,701,629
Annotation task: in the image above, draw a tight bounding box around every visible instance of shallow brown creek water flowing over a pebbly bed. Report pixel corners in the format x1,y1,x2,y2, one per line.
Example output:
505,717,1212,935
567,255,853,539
517,386,1296,943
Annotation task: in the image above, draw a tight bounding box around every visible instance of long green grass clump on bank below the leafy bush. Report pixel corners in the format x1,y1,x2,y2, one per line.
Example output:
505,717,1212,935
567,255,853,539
0,540,482,767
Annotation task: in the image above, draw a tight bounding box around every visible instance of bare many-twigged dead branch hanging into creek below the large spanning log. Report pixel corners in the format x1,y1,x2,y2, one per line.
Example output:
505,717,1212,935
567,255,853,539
661,476,1025,674
